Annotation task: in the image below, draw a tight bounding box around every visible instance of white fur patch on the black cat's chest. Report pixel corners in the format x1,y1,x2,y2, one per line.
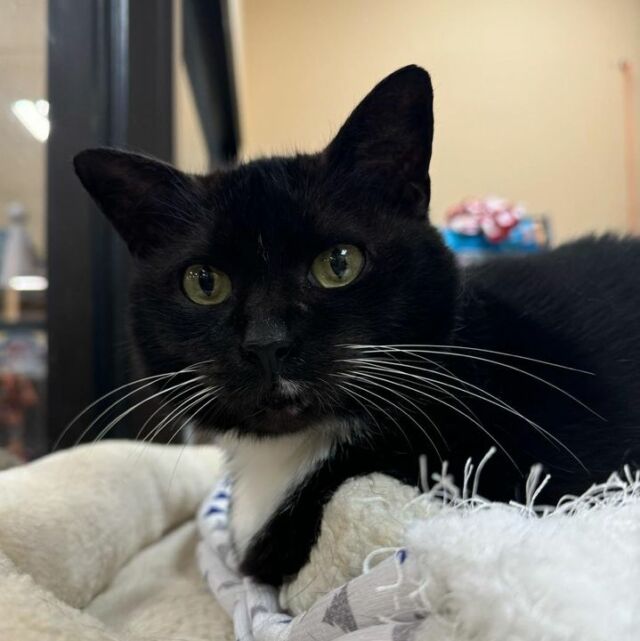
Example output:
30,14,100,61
219,430,335,556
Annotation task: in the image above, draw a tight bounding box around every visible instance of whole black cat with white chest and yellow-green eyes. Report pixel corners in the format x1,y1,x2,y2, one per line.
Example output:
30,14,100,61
75,66,640,584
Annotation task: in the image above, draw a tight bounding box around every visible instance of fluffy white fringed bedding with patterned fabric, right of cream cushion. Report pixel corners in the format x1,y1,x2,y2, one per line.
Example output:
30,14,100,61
198,460,640,641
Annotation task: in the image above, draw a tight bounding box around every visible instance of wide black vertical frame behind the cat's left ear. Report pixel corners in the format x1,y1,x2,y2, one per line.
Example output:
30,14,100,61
47,0,173,446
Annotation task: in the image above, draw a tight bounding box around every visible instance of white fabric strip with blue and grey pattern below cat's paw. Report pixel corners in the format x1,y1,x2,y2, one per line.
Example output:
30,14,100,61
197,480,427,641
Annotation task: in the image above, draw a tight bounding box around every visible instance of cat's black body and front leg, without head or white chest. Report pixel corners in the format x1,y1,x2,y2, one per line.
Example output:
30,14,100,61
232,237,640,584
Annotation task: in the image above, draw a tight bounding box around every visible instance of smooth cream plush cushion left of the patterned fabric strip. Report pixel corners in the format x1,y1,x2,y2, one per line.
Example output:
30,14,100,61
0,441,233,641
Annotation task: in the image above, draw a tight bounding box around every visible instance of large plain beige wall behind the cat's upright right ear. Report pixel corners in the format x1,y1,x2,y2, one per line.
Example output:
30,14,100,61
234,0,640,239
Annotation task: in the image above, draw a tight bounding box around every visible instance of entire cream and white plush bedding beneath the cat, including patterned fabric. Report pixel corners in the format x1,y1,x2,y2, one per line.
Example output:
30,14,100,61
0,442,640,641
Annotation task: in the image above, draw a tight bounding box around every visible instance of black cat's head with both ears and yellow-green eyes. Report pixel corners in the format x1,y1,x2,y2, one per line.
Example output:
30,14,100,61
75,66,457,434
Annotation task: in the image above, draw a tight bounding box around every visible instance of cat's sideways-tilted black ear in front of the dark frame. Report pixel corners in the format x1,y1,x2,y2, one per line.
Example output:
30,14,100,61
73,148,196,256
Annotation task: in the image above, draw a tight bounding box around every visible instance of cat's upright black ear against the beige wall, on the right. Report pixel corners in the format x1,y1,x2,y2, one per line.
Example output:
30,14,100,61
325,65,433,215
